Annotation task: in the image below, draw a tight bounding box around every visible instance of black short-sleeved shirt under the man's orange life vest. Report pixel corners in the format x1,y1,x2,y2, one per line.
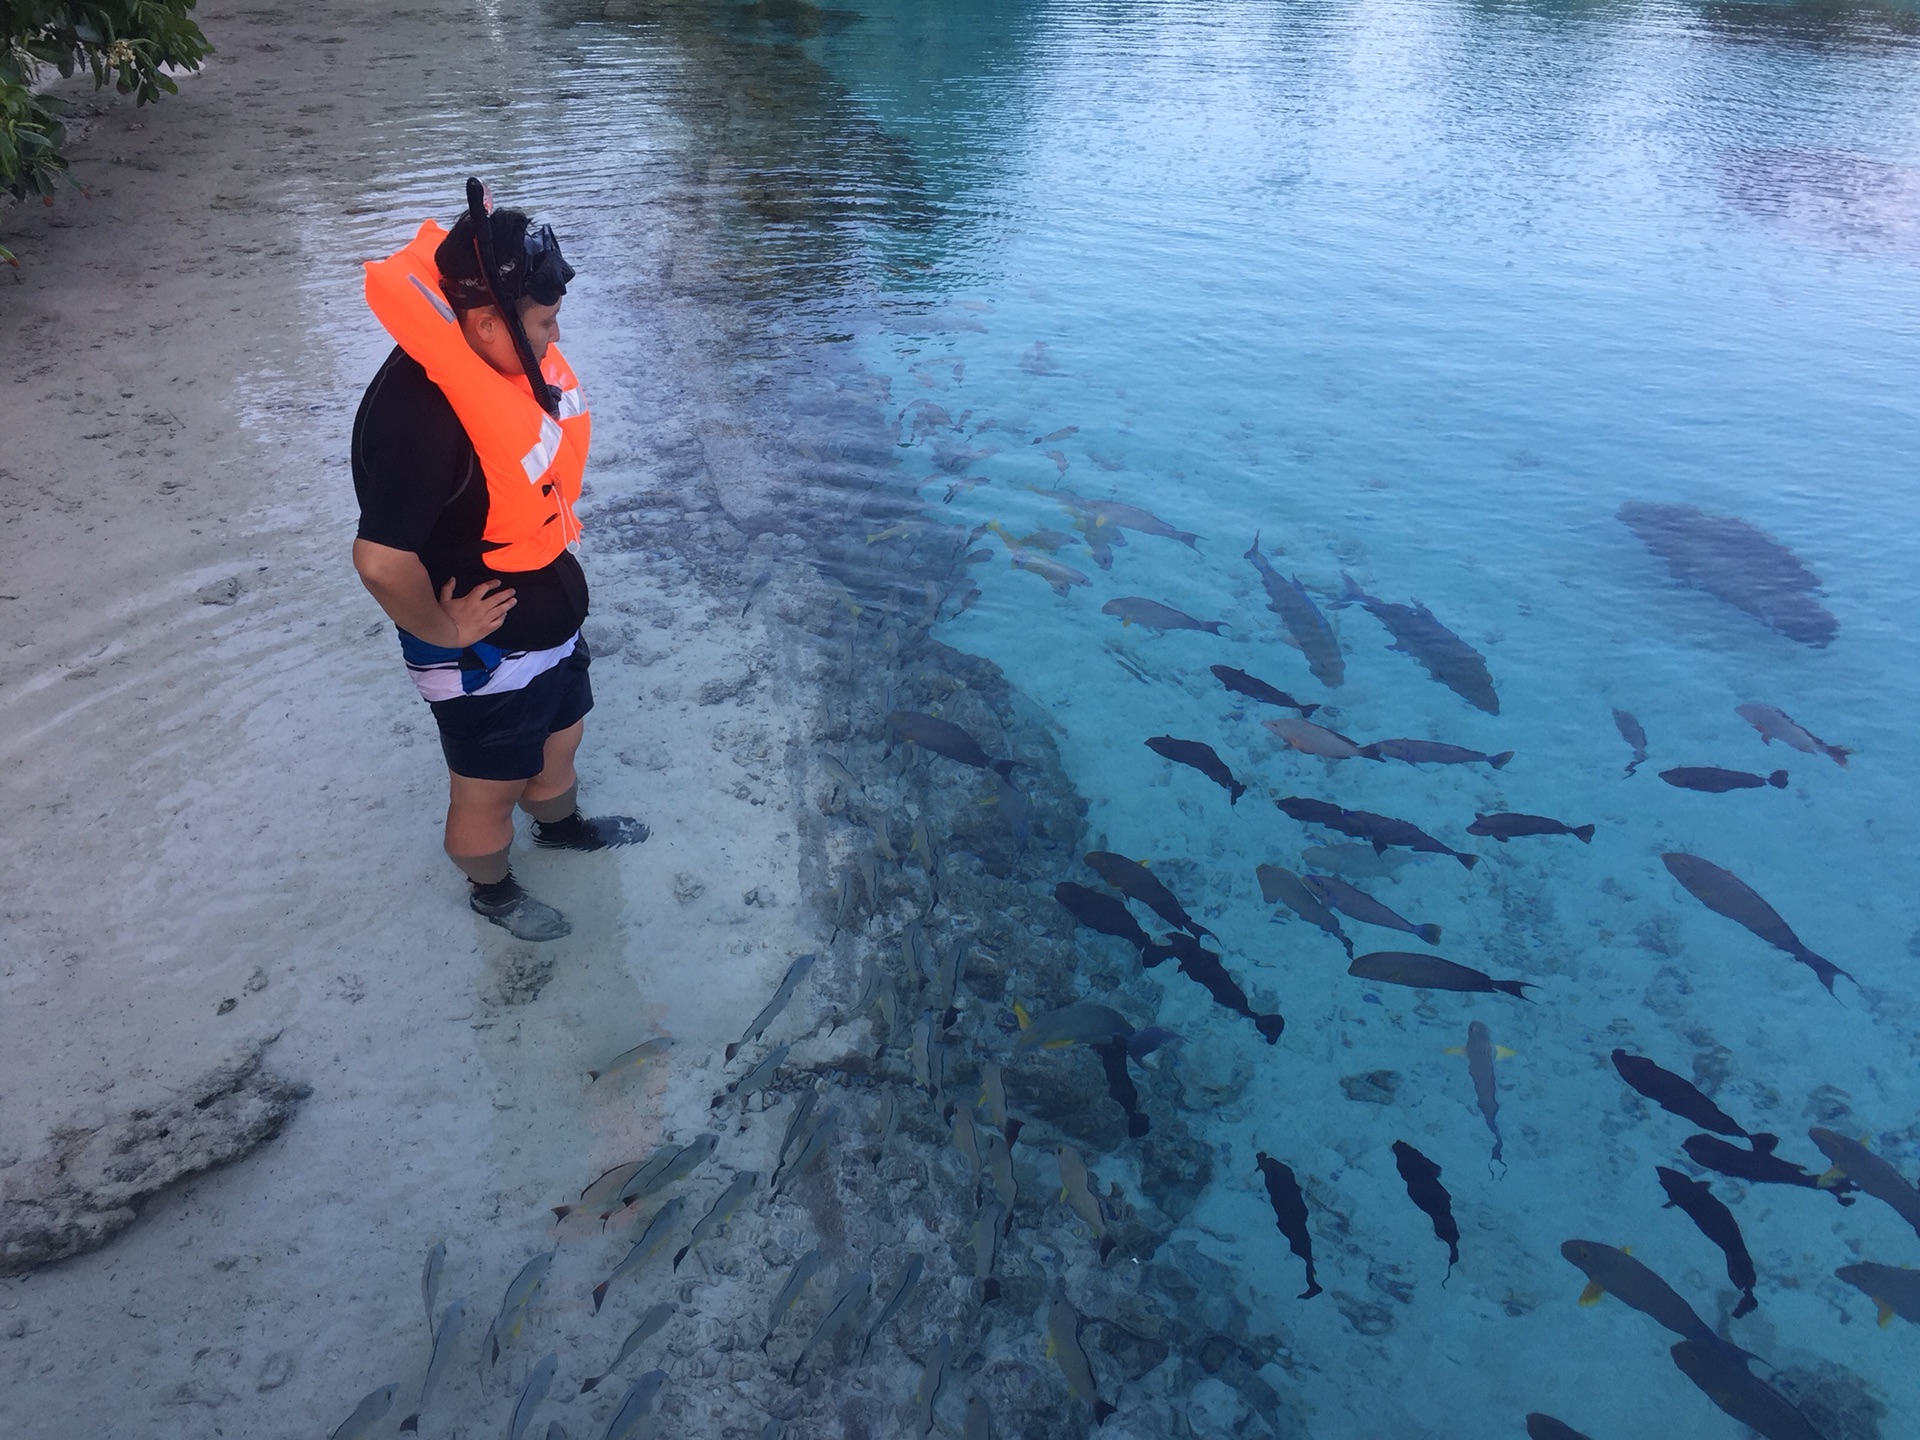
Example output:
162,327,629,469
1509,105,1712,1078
353,346,588,651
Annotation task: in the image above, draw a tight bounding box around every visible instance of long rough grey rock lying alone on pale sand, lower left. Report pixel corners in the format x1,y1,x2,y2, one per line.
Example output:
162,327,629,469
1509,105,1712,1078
0,1041,311,1275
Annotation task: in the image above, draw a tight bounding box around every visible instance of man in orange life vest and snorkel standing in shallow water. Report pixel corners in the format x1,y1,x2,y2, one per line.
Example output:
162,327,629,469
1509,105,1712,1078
353,180,647,941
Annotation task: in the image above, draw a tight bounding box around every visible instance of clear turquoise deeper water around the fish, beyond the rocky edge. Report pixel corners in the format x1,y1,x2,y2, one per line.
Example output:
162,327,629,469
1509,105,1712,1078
775,0,1920,1440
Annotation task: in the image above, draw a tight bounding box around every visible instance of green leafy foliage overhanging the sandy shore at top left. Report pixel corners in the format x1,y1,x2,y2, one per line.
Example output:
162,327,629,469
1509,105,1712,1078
0,0,213,263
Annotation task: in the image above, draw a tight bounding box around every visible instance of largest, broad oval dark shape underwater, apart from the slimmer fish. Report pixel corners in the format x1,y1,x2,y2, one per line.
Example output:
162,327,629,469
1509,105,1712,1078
1620,501,1839,647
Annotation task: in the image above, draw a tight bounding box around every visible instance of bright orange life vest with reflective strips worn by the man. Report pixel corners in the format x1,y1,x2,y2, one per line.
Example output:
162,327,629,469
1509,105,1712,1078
367,221,593,570
